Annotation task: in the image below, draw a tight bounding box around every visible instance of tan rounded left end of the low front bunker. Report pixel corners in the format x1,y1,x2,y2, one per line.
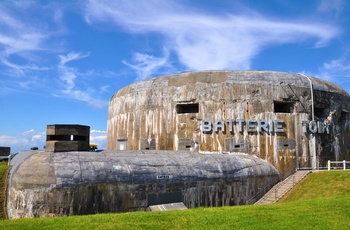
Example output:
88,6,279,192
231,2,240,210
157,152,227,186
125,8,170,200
7,152,56,219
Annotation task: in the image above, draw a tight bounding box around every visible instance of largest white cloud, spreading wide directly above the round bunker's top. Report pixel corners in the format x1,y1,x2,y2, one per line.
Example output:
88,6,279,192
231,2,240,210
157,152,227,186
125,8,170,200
85,0,339,78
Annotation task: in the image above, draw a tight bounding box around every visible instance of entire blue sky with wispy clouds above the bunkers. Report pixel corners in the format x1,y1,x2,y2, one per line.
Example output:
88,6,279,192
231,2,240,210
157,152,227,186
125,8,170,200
0,0,350,153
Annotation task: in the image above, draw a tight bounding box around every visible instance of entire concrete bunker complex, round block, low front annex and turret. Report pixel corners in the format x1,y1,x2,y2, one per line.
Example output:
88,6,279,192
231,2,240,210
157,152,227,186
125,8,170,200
7,71,350,218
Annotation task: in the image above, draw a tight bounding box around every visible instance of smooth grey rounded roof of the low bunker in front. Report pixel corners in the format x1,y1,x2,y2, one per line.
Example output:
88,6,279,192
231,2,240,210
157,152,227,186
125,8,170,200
10,151,278,189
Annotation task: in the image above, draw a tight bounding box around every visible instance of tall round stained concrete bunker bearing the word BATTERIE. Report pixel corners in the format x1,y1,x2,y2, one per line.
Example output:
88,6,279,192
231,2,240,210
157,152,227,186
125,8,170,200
107,71,350,174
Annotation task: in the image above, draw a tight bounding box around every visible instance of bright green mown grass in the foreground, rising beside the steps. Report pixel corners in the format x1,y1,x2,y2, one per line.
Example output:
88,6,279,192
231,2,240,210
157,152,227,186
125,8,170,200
0,171,350,229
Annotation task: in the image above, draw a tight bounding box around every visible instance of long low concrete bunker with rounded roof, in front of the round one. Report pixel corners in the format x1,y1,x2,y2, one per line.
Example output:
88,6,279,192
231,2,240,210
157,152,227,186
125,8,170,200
7,151,279,218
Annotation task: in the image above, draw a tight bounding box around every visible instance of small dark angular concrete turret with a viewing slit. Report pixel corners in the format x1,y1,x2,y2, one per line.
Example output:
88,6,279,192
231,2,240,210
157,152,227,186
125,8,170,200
45,124,90,152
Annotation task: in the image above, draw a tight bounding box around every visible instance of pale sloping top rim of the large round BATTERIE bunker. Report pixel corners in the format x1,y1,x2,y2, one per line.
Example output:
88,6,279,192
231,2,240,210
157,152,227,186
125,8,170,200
111,70,348,100
